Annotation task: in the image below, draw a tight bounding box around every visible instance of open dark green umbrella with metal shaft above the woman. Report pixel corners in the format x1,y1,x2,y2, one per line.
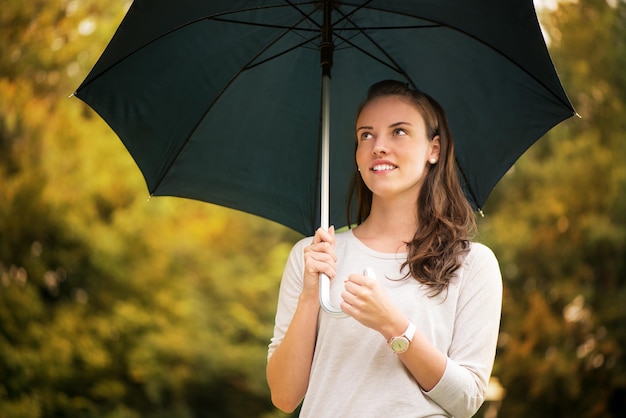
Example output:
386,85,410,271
75,0,575,310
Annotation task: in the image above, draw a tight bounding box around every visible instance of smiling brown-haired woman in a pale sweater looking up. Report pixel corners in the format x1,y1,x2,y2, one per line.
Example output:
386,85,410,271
267,81,502,418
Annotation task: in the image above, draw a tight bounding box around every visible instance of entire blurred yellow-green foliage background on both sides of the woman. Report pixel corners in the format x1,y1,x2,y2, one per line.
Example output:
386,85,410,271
0,0,626,418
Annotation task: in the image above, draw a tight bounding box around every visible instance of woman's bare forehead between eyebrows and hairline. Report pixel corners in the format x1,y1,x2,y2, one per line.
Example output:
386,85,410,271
357,96,424,125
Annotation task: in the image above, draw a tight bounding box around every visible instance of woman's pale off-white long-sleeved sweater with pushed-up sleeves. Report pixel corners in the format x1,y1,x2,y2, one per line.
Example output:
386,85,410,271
268,231,502,418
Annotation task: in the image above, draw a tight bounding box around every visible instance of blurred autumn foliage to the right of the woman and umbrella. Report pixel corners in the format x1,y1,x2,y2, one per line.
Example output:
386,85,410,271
481,0,626,417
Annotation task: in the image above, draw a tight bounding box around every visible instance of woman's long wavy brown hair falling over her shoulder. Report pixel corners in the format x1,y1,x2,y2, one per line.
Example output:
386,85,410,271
348,80,476,295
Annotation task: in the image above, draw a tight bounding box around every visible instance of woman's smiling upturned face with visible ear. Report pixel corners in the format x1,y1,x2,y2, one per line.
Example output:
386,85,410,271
356,96,439,202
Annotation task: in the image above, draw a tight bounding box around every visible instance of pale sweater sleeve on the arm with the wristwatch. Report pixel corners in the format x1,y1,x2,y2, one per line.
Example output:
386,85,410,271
425,244,502,418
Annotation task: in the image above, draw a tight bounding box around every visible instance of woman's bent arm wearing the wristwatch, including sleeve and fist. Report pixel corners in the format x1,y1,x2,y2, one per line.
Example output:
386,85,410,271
342,246,502,418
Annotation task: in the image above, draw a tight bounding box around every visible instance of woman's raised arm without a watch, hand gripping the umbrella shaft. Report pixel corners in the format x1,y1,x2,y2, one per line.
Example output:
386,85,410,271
267,228,335,412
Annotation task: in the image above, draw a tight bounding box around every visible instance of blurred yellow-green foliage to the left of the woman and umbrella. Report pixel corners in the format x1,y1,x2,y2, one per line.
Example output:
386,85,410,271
0,0,297,418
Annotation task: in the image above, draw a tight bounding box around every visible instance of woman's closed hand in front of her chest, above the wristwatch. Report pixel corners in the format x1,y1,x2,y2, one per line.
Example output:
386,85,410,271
341,273,408,337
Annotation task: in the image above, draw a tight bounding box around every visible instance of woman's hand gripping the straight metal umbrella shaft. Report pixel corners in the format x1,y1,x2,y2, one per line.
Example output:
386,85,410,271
302,226,337,295
